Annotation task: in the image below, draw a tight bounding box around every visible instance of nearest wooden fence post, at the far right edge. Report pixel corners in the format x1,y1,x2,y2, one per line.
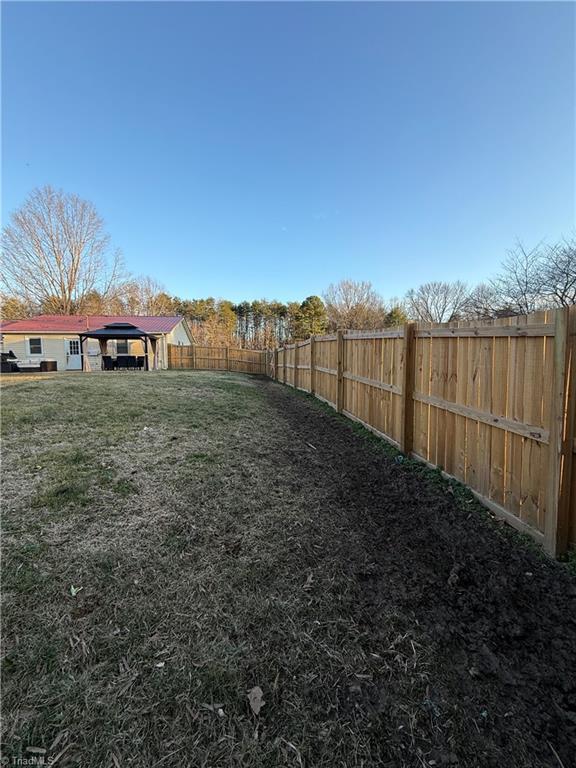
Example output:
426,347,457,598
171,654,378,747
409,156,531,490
544,309,574,556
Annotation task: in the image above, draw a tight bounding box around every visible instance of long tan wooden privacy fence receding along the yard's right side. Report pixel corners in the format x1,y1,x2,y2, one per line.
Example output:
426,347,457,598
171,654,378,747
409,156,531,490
273,307,576,554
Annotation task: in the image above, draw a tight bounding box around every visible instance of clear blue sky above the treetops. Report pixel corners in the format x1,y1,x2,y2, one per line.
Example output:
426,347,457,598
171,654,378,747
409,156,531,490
2,2,575,301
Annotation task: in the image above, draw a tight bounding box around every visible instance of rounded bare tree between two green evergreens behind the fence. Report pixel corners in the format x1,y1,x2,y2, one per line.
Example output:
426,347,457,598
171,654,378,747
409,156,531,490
324,280,388,330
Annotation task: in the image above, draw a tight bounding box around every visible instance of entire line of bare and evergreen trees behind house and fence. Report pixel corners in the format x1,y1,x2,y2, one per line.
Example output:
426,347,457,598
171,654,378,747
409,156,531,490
0,186,576,348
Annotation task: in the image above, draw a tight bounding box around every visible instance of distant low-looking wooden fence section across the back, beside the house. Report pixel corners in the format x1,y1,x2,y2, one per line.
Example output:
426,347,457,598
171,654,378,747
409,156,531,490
168,344,271,374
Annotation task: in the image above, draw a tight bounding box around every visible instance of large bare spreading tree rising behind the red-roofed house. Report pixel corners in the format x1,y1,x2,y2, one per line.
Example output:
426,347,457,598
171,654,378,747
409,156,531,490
1,186,121,314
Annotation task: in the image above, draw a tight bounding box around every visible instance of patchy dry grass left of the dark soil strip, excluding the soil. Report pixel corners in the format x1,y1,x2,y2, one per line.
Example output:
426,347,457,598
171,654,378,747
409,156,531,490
3,372,412,768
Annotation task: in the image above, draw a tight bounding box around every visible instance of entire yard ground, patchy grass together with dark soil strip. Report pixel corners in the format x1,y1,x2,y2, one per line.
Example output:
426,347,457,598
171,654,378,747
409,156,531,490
2,371,576,768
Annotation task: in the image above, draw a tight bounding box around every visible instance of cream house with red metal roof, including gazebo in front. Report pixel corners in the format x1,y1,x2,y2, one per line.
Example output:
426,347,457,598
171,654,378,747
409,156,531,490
0,315,192,371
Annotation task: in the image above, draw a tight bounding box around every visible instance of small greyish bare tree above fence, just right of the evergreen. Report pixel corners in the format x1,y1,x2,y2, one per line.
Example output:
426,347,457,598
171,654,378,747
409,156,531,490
406,280,470,323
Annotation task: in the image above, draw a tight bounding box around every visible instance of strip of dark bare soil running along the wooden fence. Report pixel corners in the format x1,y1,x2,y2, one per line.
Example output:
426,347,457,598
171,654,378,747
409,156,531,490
269,380,576,768
